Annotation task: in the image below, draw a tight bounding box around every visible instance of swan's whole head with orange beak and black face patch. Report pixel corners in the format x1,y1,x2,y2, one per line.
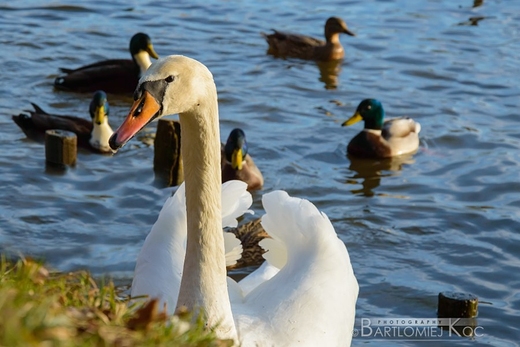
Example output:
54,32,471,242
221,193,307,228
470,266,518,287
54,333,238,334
109,55,217,150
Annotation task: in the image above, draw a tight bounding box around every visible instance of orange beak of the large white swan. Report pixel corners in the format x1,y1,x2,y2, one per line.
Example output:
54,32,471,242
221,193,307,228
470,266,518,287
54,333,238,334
108,91,161,151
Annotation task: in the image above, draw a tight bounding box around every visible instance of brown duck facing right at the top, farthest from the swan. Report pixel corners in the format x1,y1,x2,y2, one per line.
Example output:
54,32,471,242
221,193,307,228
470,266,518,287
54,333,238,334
262,17,356,61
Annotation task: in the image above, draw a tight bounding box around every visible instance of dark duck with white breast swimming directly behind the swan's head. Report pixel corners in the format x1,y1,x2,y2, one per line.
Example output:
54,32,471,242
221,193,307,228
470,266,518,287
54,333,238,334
54,33,159,93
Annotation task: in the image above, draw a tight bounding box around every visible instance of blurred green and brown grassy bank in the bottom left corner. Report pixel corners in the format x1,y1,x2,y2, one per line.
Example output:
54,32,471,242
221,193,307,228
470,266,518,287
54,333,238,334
0,257,232,347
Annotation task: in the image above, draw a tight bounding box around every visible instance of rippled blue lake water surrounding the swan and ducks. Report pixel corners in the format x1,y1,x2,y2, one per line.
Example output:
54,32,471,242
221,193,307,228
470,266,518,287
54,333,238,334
0,0,520,346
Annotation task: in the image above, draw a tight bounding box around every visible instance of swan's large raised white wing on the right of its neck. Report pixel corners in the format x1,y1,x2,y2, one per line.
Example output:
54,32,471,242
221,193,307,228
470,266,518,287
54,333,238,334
233,191,358,346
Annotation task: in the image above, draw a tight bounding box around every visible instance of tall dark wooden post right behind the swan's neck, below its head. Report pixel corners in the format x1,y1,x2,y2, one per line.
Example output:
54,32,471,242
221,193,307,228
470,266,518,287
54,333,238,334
153,119,184,186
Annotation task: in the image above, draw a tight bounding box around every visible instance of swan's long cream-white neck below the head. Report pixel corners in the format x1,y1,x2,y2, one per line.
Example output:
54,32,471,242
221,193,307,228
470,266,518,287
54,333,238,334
176,91,237,340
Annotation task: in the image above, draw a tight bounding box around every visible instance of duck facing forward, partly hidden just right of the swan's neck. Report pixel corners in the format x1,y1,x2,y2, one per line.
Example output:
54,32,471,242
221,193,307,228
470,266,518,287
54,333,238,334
221,128,264,191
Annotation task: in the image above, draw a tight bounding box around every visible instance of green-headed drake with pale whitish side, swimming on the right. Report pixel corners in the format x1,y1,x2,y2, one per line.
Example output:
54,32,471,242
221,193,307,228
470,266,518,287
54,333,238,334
342,99,421,158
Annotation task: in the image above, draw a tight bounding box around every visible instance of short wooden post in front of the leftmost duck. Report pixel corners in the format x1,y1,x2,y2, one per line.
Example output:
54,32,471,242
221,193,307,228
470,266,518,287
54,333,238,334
45,130,78,165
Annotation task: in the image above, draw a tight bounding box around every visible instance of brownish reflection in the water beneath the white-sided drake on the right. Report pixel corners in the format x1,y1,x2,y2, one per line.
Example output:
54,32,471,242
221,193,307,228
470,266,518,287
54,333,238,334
345,153,415,197
